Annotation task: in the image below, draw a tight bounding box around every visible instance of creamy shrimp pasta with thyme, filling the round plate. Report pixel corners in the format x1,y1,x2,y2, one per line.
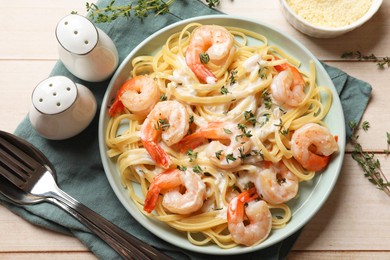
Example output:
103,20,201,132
105,23,338,248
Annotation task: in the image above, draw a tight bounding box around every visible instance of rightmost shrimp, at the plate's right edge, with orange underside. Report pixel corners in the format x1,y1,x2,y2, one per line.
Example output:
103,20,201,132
291,123,339,171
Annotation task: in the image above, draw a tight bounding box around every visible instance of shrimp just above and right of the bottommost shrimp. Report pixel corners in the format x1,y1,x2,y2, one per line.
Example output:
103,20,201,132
256,162,299,204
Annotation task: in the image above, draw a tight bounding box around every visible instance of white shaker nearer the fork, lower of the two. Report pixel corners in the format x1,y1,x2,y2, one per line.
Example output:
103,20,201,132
29,76,97,140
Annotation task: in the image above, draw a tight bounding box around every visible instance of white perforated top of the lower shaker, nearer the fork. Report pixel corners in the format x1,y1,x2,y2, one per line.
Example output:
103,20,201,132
32,76,77,115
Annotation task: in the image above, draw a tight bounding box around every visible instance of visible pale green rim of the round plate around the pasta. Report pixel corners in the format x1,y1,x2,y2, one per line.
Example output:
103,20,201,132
99,15,345,255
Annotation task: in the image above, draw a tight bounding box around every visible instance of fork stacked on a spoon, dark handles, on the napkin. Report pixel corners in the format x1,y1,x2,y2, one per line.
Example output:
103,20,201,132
0,131,170,259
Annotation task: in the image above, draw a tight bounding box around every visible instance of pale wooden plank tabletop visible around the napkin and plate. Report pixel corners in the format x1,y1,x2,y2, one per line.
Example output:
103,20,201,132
0,0,390,259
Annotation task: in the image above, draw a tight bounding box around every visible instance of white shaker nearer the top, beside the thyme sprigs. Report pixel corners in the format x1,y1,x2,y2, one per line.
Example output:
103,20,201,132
56,14,119,82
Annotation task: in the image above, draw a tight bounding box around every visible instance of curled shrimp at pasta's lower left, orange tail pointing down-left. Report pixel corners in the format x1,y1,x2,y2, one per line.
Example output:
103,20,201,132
144,169,206,214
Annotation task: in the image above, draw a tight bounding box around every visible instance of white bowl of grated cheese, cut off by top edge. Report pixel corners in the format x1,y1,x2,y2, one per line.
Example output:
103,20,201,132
279,0,383,38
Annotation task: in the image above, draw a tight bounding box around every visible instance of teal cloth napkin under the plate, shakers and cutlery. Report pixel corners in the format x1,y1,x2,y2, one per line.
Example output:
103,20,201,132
0,0,371,260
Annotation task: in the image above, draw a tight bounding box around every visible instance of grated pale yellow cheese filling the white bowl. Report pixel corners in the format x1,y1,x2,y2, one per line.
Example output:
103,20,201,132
286,0,372,28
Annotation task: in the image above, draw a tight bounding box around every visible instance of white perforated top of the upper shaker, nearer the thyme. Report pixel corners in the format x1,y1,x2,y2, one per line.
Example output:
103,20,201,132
56,14,99,55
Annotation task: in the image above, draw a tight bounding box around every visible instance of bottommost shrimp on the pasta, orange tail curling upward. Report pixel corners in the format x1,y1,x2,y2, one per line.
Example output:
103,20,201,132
227,188,272,246
